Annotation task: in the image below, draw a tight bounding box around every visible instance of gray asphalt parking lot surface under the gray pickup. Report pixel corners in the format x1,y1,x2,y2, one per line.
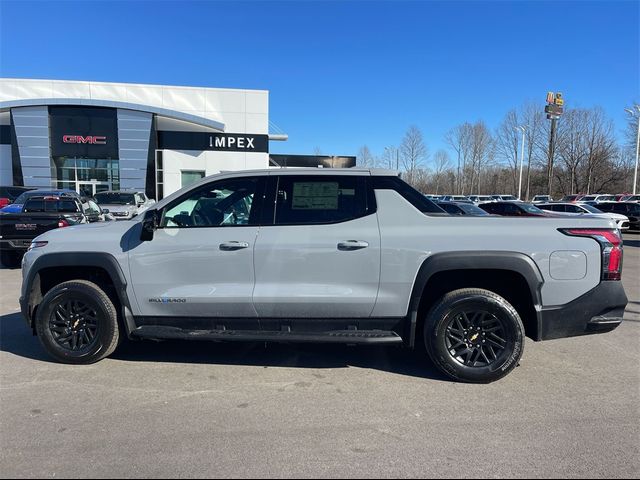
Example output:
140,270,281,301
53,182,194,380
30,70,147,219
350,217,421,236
0,234,640,478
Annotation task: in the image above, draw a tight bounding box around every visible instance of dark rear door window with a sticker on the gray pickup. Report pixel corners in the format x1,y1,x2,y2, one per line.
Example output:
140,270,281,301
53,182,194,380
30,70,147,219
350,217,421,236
275,175,368,225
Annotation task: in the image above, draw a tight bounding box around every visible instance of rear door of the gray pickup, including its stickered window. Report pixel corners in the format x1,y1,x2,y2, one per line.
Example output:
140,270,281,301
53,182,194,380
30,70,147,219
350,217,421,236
253,175,380,319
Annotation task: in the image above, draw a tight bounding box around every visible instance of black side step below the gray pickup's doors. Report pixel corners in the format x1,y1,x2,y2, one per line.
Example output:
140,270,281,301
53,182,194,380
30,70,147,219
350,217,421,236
132,325,402,344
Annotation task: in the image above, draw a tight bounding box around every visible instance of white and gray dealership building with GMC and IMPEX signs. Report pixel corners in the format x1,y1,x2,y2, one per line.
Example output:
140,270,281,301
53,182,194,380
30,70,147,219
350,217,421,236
0,78,355,199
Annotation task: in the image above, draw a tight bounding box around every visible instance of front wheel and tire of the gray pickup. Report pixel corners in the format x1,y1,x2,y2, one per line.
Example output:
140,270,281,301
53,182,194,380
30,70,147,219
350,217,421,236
35,280,120,365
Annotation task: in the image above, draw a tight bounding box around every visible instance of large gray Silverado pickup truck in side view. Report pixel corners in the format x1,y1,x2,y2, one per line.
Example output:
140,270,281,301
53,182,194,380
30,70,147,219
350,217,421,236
20,169,627,382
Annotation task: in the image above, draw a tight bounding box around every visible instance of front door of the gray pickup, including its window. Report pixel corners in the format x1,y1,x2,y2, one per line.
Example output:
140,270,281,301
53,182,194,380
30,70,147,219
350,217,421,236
129,177,264,318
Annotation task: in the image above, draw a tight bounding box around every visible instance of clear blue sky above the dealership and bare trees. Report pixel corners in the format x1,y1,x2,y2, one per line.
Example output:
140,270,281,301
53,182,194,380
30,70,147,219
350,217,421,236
0,0,640,162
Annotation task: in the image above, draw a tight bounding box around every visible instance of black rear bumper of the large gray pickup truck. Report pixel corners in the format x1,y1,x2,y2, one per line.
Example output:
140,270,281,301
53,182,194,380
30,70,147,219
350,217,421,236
538,281,627,340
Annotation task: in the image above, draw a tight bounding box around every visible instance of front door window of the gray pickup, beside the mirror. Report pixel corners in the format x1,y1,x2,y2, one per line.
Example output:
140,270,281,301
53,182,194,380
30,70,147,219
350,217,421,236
160,178,259,228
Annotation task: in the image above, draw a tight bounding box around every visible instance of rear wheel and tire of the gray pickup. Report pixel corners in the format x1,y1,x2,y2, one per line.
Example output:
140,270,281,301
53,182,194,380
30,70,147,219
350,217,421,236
424,288,525,383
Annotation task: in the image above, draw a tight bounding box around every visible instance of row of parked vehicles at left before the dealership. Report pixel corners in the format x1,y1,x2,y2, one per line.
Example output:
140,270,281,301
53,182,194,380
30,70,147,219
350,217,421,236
0,187,155,267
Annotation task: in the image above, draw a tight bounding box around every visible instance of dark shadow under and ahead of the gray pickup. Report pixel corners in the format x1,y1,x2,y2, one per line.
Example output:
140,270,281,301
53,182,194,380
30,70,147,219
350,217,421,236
0,313,451,382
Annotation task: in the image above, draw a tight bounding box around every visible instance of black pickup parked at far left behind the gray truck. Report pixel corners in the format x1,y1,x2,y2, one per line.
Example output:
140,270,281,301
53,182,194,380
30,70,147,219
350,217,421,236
0,195,103,267
